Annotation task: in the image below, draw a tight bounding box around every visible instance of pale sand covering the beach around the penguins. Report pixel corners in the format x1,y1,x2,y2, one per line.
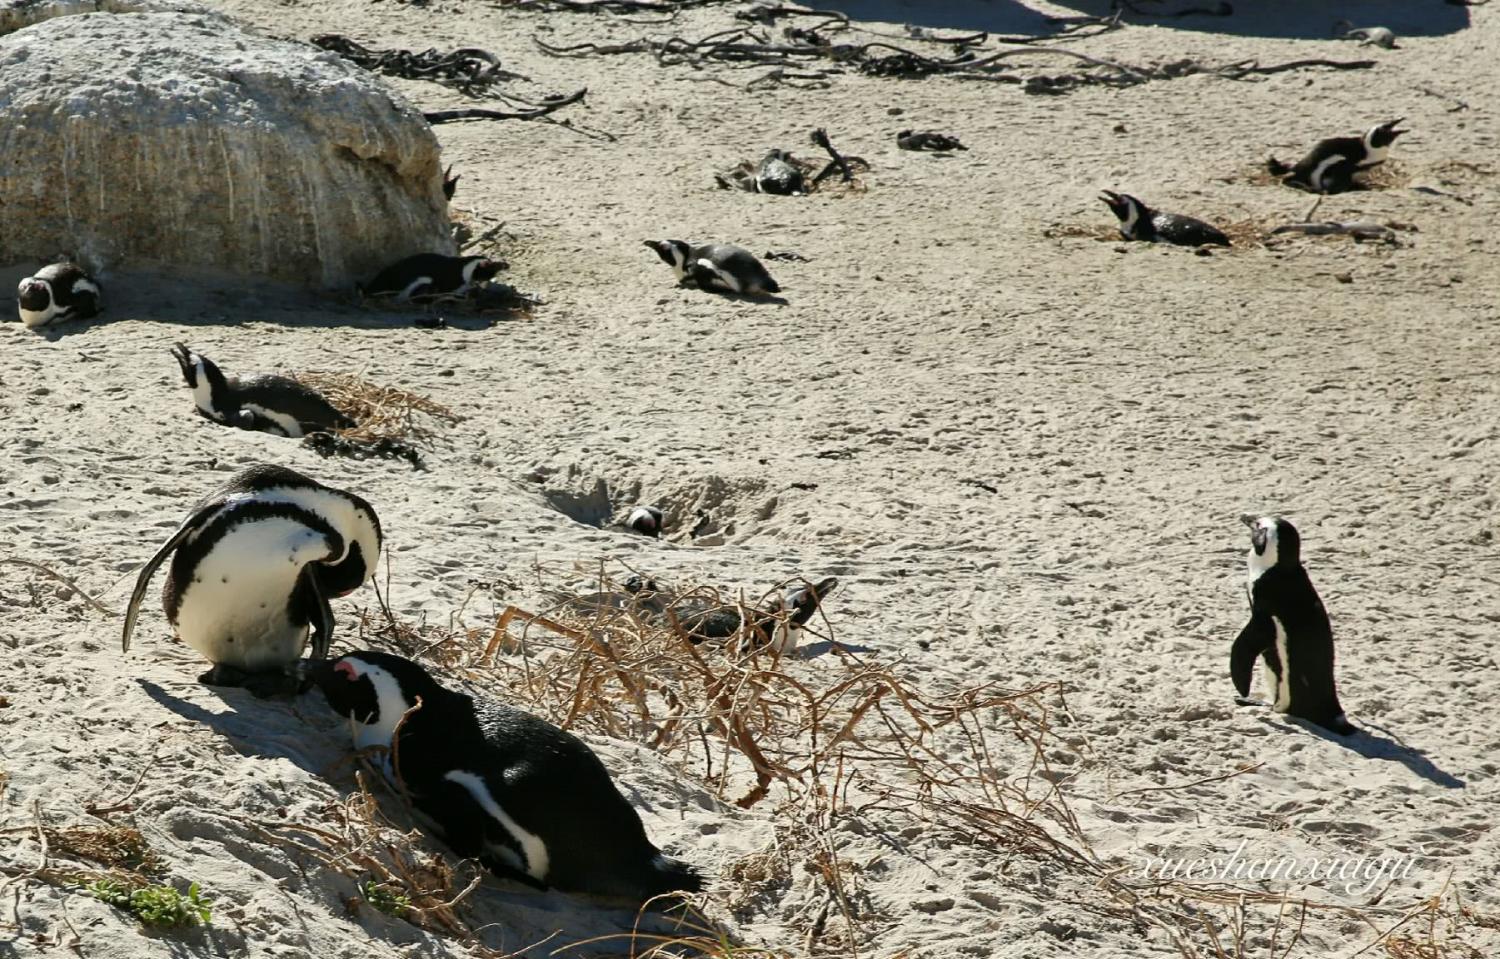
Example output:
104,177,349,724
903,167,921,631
0,0,1500,959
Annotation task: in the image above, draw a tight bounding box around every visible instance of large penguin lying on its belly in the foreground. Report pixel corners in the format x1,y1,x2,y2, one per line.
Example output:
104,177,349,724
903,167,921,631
309,650,704,905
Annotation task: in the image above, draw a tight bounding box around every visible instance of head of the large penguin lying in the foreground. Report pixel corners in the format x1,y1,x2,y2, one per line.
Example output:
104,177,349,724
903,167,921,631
310,650,443,746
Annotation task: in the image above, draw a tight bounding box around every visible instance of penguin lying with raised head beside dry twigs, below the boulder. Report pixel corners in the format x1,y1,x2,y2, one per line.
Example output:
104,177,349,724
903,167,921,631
171,344,356,438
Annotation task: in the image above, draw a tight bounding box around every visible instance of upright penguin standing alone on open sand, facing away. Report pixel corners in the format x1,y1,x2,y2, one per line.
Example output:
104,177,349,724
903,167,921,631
1230,516,1358,735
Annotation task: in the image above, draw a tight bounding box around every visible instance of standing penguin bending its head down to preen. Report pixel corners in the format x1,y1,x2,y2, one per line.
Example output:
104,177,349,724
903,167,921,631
120,464,383,698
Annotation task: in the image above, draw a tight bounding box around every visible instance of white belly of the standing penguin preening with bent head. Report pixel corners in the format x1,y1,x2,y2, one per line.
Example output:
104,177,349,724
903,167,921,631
176,519,329,672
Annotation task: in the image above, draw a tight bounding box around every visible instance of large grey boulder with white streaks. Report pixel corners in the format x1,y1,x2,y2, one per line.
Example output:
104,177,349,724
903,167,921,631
0,12,453,288
